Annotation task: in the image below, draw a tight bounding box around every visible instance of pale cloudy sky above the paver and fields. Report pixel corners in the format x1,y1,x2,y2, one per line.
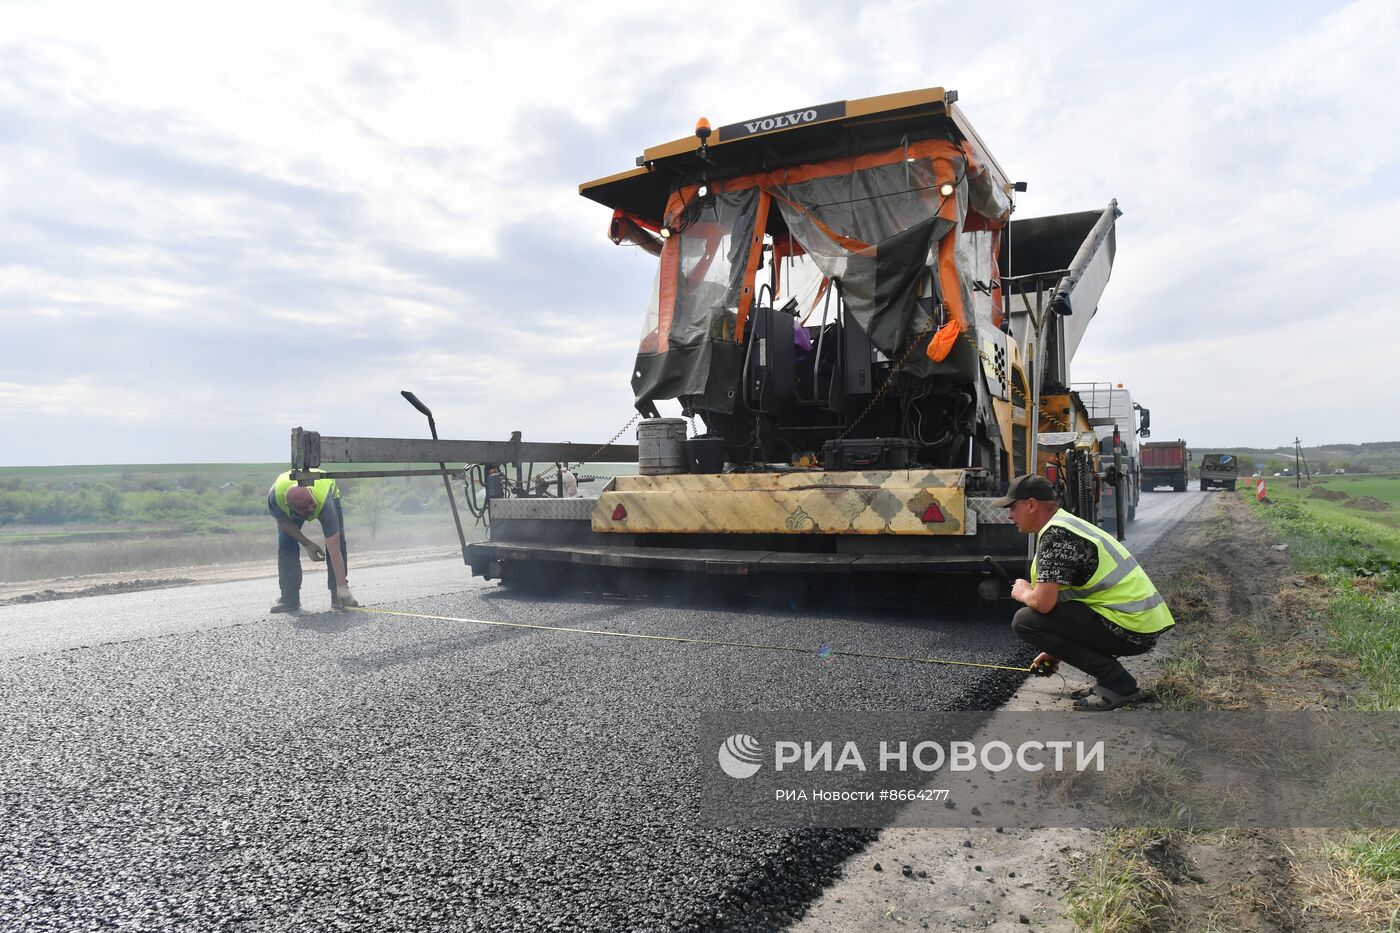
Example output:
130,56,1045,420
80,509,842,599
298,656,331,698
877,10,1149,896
0,0,1400,465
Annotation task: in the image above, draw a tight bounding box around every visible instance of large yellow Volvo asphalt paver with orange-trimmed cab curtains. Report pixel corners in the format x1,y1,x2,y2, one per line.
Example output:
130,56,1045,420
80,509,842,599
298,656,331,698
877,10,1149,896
293,88,1120,598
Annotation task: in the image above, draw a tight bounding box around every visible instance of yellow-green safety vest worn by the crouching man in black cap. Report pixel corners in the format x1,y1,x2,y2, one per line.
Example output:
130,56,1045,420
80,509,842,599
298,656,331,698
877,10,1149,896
1030,509,1176,635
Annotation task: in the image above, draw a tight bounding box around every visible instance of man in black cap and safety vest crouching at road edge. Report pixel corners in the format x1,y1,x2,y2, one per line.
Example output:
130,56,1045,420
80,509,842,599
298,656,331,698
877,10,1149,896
997,475,1176,710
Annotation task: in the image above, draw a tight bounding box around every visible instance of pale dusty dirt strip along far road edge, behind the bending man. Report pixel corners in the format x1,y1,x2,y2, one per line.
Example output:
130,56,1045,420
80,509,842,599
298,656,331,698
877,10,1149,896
0,548,461,605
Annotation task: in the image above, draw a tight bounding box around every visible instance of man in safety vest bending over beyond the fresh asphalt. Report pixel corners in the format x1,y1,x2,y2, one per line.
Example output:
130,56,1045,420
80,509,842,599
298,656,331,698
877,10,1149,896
267,471,360,612
